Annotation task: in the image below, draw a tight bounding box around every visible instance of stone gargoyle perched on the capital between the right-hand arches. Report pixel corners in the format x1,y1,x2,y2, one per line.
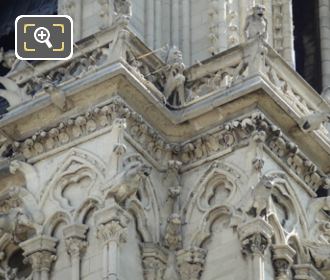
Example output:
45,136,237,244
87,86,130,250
247,176,274,217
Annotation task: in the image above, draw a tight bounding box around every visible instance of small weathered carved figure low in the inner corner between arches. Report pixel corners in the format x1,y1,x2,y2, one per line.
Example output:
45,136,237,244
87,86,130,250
164,213,182,250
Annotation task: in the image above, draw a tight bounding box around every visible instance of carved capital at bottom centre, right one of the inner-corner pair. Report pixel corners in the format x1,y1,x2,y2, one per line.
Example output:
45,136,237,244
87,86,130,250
176,247,207,280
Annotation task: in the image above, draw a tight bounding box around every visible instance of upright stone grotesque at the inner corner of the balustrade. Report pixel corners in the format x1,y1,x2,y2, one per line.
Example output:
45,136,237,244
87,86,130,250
164,46,186,107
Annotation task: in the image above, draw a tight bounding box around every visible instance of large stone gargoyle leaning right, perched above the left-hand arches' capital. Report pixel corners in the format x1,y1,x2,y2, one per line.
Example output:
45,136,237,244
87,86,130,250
108,161,151,204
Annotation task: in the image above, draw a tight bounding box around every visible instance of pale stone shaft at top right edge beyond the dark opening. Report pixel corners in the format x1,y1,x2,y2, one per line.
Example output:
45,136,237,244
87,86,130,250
319,0,330,90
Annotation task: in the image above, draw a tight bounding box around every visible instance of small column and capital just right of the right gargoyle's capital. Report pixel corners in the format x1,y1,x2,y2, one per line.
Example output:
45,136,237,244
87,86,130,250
272,245,296,280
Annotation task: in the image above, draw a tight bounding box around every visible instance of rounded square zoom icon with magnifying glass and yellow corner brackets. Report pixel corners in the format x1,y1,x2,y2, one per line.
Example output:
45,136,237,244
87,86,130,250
15,15,73,60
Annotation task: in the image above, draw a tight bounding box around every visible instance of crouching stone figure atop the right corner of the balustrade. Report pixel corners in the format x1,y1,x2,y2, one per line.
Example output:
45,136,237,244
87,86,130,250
244,5,268,40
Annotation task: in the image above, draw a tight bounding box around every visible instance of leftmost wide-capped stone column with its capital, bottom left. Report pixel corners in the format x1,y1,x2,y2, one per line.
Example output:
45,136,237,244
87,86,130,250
20,235,57,280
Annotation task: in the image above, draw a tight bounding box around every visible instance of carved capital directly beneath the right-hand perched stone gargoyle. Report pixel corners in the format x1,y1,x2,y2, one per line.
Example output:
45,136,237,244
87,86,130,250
237,218,273,255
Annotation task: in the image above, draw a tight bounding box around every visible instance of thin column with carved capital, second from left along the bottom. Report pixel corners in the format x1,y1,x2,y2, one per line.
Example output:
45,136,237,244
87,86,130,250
63,224,88,280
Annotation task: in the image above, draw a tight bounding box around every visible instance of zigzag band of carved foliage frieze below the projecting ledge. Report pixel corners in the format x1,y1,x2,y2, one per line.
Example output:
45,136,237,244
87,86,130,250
1,97,327,195
